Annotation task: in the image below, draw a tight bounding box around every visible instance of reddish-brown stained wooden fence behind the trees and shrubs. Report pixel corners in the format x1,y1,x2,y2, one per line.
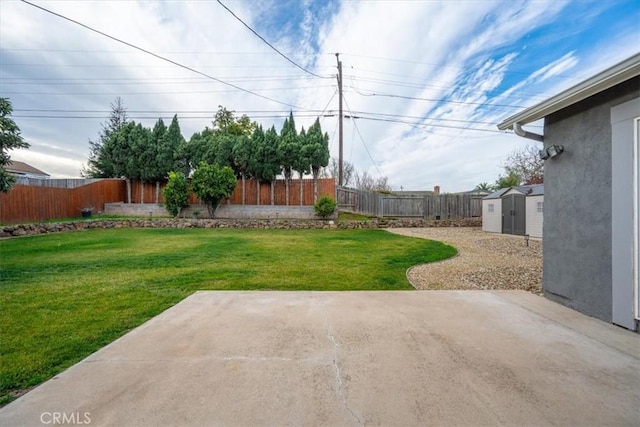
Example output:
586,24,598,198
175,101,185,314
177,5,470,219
0,178,336,224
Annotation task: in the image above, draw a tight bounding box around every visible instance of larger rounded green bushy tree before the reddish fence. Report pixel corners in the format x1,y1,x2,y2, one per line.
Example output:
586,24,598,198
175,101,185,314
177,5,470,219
191,162,237,218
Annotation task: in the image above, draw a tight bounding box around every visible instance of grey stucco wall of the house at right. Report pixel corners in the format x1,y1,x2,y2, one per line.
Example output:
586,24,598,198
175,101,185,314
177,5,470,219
543,78,640,321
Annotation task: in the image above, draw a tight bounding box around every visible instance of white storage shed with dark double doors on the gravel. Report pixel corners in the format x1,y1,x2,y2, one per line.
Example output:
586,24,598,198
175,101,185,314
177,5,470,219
482,184,544,238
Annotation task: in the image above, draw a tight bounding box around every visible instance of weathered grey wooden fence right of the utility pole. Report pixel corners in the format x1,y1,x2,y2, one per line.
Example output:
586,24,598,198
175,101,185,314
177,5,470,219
336,187,482,219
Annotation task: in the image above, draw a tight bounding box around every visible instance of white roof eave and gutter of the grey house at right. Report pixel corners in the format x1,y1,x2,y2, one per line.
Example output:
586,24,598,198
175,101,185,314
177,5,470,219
498,53,640,130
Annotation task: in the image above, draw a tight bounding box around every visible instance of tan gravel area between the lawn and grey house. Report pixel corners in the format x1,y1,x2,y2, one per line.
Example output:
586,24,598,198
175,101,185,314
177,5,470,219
389,227,542,294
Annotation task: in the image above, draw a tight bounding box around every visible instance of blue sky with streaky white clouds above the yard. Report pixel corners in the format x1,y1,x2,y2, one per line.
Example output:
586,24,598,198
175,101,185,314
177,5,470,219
0,0,640,192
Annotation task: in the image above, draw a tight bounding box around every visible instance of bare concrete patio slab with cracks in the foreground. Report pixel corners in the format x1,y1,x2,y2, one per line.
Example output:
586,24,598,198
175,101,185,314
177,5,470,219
0,291,640,426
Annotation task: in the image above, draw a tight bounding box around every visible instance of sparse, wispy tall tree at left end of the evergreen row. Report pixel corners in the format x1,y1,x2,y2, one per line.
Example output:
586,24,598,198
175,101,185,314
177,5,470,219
85,97,129,178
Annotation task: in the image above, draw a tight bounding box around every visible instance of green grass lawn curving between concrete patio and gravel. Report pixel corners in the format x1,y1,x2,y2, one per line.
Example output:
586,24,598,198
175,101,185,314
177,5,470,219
0,229,456,404
